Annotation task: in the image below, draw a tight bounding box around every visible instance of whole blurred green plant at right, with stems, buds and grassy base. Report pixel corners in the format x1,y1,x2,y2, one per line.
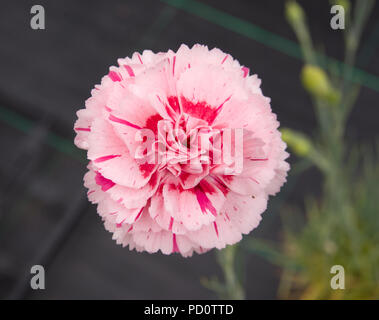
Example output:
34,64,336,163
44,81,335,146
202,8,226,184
246,0,379,299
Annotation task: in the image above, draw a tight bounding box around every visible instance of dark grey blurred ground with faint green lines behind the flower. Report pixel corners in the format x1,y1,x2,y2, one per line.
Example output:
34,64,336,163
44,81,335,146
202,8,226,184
0,0,379,299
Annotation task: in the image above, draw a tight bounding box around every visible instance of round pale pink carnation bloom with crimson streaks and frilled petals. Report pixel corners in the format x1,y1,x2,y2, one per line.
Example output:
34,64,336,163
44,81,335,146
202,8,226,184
74,45,289,256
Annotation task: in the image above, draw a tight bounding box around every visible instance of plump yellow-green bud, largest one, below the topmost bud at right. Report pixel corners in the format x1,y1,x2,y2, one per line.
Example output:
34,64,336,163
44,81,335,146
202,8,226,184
301,65,340,104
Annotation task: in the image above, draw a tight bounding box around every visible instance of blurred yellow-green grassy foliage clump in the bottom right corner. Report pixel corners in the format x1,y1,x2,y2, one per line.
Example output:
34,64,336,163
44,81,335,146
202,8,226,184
275,149,379,299
